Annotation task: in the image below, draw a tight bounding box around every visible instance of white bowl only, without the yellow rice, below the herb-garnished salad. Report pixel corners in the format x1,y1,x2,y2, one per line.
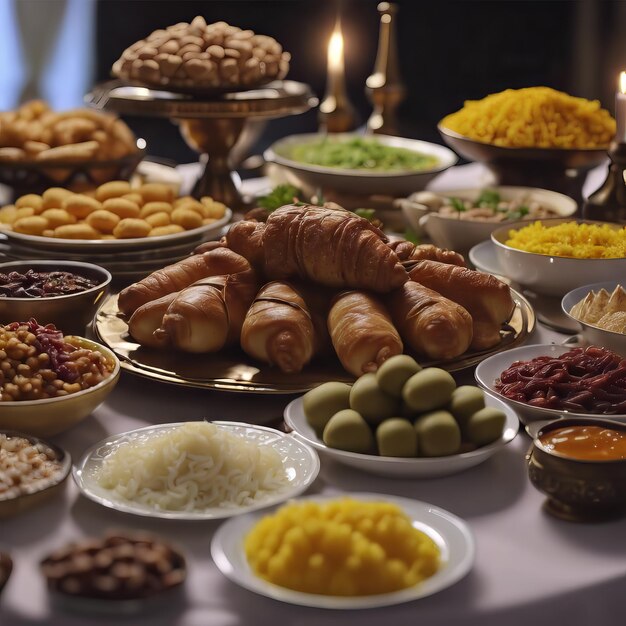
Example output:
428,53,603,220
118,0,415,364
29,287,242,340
491,219,626,296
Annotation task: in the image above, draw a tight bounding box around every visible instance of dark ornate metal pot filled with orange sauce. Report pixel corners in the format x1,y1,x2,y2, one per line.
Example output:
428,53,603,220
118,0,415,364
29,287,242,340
526,417,626,522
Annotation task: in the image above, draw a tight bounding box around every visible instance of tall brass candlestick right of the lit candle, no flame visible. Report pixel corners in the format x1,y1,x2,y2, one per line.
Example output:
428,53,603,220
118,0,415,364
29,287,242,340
365,2,406,135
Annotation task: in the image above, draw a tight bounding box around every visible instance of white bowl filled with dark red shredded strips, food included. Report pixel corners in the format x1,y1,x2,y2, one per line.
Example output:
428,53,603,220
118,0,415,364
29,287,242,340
475,344,626,424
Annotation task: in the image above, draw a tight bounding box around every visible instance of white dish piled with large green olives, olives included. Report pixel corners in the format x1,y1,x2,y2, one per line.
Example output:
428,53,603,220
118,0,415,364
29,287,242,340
284,355,519,478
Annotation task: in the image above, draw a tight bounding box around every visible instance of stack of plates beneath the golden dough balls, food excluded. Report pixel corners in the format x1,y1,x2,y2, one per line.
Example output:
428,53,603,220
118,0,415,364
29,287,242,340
0,209,232,282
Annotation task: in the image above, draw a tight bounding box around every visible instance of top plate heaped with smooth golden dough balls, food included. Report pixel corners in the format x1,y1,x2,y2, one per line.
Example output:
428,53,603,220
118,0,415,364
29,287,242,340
0,180,232,250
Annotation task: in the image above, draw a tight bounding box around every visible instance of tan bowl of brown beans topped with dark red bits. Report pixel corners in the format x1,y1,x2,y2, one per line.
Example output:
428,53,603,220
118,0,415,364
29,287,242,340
0,319,120,437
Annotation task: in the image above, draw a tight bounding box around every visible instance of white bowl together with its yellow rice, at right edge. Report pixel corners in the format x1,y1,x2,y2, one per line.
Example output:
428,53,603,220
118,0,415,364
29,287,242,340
491,218,626,296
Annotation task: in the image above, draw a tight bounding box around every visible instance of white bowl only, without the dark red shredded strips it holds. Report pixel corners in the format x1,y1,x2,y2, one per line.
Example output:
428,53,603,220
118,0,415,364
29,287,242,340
474,344,626,424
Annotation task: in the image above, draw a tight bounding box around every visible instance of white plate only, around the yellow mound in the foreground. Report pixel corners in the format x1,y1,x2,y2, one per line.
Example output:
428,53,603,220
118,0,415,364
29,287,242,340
211,493,475,609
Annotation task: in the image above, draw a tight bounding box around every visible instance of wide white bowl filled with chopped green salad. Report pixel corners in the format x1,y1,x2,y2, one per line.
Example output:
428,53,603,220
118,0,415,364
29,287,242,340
264,133,457,197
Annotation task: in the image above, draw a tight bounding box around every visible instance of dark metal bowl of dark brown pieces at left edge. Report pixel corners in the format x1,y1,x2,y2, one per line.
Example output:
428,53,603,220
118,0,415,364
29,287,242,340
0,260,111,334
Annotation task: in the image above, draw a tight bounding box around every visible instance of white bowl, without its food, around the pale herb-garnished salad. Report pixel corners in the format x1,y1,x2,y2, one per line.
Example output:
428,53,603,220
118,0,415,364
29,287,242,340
399,187,578,254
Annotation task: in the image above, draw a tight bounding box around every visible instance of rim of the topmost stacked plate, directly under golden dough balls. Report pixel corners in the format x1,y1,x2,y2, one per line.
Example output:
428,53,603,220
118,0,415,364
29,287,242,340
2,209,232,253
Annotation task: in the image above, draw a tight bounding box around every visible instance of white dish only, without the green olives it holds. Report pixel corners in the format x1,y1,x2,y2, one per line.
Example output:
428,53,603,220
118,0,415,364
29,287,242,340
284,394,519,478
